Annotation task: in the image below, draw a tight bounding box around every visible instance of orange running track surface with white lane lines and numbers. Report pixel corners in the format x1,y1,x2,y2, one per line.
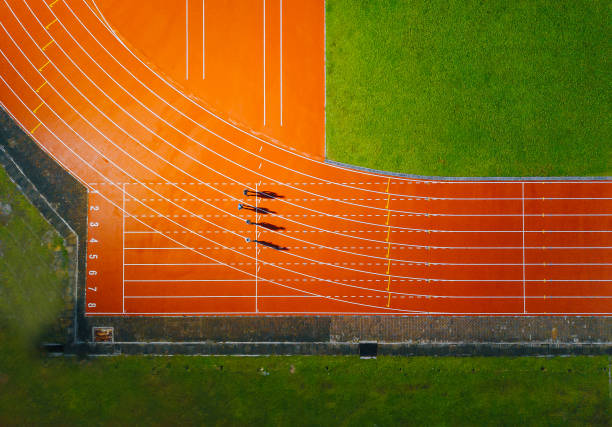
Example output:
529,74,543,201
0,0,612,315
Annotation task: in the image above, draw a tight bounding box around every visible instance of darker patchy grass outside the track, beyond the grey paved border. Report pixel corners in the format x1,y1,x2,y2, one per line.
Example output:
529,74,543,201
0,168,612,426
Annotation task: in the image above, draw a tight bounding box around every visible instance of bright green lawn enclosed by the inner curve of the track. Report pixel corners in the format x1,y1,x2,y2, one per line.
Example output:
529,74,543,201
326,0,612,176
